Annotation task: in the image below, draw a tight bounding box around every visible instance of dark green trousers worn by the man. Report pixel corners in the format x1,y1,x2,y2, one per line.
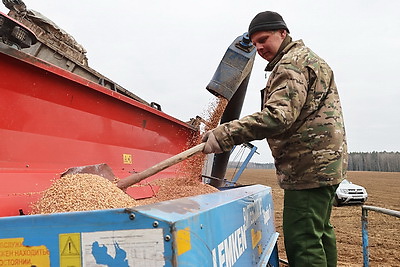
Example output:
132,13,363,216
283,185,338,267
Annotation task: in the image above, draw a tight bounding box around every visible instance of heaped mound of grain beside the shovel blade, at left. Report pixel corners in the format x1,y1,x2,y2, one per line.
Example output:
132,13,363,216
32,173,137,214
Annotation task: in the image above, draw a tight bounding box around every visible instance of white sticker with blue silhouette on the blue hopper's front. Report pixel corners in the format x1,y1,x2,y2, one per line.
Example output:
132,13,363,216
82,229,165,267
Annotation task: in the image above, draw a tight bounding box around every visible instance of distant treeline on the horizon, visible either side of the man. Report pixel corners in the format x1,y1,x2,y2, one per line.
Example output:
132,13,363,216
228,151,400,172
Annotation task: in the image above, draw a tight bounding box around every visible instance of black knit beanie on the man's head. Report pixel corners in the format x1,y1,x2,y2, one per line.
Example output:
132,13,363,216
249,11,289,38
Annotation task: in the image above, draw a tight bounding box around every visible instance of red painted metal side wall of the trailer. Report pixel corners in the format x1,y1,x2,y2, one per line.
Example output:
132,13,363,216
0,44,198,216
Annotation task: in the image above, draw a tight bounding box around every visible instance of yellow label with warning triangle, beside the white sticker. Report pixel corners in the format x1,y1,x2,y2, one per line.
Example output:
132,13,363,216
58,233,82,267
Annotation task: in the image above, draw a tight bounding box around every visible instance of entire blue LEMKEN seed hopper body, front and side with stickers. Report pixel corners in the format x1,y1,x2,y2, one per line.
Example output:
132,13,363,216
0,185,278,267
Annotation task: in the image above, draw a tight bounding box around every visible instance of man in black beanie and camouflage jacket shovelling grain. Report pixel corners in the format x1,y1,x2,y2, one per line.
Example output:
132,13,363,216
203,11,347,267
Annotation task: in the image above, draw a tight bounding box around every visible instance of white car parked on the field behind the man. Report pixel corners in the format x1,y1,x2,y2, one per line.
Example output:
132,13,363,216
334,179,368,206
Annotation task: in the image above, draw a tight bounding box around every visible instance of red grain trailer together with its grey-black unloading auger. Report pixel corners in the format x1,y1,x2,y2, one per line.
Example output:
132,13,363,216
0,6,255,219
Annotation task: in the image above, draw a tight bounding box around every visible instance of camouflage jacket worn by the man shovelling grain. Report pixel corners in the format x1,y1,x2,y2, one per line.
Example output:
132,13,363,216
213,40,347,190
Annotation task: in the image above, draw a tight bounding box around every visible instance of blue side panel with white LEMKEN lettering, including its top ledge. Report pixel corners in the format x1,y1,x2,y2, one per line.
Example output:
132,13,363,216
137,185,277,266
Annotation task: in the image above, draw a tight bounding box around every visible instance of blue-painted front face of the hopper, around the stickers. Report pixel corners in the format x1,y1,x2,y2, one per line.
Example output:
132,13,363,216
0,209,172,267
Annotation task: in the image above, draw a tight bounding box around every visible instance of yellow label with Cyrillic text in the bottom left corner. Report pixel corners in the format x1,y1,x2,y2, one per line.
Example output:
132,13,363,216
0,237,50,267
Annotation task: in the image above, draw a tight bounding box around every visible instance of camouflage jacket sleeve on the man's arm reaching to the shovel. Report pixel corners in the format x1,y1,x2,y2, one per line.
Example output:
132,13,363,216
213,63,308,151
